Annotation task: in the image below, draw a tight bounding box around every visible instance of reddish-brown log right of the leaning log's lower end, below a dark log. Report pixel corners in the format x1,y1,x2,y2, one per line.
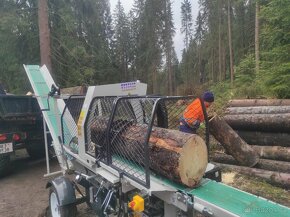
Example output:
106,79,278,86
252,145,290,162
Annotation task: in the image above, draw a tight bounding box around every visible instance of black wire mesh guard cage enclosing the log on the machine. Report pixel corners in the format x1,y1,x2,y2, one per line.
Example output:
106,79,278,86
85,97,206,187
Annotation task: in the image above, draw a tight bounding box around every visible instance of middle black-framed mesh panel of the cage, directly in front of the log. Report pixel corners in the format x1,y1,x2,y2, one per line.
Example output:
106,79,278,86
107,97,158,186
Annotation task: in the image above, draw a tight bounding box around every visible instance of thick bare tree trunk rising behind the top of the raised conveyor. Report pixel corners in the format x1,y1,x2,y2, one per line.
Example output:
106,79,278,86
38,0,52,72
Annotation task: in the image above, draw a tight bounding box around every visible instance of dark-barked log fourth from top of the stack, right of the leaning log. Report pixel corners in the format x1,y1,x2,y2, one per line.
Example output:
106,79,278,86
236,130,290,147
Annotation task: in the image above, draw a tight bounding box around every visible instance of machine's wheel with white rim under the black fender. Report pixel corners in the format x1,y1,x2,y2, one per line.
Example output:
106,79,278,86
49,187,77,217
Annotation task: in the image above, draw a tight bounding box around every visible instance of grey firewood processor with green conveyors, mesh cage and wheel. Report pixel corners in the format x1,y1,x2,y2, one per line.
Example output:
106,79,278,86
24,65,290,217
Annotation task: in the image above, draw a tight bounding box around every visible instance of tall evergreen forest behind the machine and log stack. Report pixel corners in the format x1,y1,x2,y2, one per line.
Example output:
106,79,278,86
0,0,290,98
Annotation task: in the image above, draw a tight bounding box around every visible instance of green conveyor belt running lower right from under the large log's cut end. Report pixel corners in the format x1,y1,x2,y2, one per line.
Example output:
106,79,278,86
152,170,290,217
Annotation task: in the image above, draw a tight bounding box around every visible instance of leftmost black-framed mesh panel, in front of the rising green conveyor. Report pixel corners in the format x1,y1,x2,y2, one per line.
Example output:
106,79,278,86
61,95,85,153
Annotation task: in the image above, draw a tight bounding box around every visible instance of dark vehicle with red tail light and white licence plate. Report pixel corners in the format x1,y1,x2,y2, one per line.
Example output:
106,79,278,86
0,91,45,176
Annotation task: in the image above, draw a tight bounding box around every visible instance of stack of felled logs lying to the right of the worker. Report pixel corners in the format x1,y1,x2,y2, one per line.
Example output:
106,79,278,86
211,99,290,188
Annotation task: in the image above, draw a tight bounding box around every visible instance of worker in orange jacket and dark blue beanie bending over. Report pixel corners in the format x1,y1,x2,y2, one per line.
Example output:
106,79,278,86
179,91,214,134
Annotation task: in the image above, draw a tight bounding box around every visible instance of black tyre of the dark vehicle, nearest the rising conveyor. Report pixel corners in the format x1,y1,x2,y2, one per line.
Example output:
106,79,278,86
26,140,45,159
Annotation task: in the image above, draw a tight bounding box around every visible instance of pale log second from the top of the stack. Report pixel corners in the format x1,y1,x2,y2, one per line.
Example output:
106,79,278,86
225,106,290,115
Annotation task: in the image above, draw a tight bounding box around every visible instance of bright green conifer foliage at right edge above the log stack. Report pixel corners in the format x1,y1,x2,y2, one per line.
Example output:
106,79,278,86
261,0,290,98
